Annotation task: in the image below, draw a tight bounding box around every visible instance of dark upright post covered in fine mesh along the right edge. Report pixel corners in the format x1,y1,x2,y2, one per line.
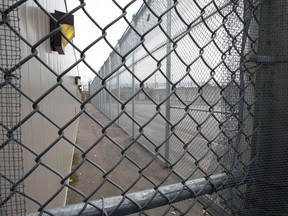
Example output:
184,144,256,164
244,0,288,215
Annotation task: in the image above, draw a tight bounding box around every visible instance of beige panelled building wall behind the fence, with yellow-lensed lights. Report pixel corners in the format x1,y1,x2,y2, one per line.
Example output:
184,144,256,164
19,0,80,212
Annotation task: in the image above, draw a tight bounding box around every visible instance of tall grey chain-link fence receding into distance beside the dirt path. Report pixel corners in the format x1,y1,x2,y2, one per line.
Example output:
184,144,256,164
91,1,259,213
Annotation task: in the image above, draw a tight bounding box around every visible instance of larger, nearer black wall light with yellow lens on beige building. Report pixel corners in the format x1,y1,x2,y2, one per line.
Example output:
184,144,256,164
50,10,75,54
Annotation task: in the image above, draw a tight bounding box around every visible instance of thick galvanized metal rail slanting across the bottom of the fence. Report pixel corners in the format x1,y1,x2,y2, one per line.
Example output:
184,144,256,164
27,174,231,216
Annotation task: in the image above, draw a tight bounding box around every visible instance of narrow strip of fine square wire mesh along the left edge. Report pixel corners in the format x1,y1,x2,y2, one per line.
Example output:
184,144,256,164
0,1,25,215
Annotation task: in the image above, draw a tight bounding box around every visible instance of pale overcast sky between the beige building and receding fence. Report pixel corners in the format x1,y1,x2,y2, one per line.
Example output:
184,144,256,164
67,0,143,87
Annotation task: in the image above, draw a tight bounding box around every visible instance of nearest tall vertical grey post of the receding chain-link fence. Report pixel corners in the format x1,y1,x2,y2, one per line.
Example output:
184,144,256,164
165,0,171,166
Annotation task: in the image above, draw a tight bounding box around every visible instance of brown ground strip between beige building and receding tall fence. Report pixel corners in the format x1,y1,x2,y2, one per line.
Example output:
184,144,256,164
67,104,206,216
